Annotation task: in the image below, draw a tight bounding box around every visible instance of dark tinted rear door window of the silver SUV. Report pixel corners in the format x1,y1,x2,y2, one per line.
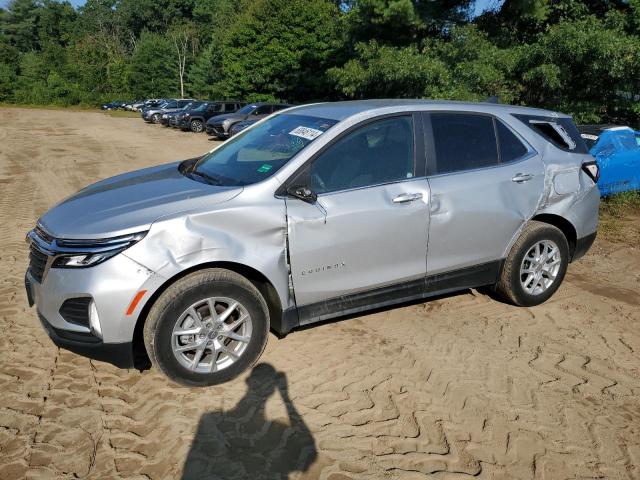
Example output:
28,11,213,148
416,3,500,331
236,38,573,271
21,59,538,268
429,113,499,174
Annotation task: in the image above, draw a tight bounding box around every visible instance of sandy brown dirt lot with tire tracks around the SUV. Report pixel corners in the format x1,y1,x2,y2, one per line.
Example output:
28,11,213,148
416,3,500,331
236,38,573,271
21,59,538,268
0,109,640,480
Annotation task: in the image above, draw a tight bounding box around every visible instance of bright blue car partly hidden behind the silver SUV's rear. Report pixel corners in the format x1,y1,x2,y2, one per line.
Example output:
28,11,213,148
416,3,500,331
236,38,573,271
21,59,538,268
580,125,640,196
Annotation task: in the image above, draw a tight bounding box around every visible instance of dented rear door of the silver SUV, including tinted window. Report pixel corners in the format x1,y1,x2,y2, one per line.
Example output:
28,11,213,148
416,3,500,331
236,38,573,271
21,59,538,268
424,113,544,275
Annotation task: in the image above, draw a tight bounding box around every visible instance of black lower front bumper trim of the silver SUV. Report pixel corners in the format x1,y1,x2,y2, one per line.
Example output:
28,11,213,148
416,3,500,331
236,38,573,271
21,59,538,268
38,312,135,368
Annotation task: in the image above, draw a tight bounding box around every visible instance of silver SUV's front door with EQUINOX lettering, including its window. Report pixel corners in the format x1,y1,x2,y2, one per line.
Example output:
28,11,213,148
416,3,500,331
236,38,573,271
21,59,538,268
286,115,429,323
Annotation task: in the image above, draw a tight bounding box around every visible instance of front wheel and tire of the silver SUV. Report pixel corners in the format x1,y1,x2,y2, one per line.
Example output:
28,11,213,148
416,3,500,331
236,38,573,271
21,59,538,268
144,268,269,387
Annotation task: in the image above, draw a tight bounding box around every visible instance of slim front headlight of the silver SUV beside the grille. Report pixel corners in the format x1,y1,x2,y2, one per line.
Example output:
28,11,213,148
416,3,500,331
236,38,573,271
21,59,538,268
51,232,147,268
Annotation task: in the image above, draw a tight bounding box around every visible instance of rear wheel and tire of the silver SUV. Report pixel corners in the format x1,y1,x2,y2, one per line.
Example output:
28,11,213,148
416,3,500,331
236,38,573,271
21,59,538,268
496,221,569,307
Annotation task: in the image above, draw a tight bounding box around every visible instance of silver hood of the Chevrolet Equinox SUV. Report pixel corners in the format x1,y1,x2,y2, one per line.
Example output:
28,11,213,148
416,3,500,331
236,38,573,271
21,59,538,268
39,162,242,239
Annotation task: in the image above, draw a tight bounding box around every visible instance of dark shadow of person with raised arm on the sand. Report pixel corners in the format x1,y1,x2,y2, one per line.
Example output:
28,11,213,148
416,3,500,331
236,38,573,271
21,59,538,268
182,363,318,480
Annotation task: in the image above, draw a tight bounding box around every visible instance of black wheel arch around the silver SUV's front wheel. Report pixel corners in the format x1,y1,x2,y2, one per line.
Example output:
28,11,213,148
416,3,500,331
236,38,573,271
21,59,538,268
133,261,283,370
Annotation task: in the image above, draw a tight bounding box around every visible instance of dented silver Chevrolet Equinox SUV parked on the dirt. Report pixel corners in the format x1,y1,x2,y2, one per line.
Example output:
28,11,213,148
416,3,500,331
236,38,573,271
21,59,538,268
26,100,599,386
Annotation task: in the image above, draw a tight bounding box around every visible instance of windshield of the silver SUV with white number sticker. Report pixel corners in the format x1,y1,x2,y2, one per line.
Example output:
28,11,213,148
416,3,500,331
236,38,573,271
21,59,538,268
185,114,338,186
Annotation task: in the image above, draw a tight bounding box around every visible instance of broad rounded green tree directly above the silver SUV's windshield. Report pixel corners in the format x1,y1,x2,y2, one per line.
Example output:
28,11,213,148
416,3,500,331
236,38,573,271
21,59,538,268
216,0,342,101
